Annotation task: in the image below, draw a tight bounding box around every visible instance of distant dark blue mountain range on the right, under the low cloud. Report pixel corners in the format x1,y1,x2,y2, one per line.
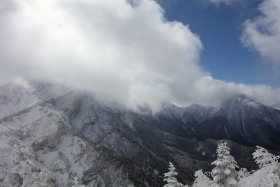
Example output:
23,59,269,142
156,95,280,149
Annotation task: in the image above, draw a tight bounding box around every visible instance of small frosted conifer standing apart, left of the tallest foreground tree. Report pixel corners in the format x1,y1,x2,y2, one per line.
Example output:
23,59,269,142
163,162,183,187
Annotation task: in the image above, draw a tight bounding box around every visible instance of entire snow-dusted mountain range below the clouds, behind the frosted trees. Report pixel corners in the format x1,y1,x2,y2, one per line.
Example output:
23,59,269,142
0,83,280,187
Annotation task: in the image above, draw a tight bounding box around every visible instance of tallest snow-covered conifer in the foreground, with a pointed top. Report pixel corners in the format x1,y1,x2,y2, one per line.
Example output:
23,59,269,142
211,142,238,187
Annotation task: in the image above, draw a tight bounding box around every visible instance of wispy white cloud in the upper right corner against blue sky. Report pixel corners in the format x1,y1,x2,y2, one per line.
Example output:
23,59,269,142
242,0,280,64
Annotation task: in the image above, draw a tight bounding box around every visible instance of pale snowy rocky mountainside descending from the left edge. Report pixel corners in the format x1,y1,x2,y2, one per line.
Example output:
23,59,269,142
0,85,132,187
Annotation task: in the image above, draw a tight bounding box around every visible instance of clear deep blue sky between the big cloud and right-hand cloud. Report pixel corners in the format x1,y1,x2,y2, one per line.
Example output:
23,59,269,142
158,0,280,87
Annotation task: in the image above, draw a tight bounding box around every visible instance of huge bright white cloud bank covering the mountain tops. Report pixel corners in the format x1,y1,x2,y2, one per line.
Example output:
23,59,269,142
0,0,280,110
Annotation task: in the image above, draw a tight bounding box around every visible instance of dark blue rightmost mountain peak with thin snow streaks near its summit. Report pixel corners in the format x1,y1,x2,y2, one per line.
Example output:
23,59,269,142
196,96,280,149
